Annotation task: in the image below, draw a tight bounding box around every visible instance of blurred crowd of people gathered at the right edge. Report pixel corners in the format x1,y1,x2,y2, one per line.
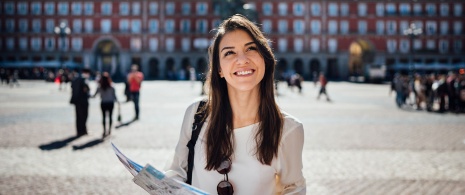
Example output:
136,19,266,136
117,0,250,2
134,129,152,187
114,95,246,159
391,72,465,113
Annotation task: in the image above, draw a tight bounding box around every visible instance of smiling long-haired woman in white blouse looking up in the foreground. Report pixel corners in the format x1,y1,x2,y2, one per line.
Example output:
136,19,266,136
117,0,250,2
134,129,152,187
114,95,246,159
166,15,306,194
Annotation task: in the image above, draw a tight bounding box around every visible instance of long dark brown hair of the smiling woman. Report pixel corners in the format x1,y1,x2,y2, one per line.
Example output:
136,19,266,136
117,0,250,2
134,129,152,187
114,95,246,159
205,15,283,170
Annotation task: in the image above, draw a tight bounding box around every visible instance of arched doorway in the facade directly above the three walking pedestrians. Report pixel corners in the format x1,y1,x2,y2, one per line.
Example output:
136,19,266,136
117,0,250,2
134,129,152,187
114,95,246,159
93,40,118,79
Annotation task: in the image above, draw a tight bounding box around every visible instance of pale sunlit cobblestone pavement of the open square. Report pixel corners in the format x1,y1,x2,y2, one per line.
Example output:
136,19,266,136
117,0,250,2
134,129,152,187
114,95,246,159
0,81,465,195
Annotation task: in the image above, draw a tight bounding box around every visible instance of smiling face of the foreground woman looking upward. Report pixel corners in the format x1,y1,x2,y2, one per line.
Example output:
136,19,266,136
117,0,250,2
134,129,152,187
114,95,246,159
219,30,265,91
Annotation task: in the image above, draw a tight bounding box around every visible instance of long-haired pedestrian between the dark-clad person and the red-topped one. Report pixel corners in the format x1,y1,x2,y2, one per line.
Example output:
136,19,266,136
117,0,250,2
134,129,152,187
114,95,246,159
92,72,118,139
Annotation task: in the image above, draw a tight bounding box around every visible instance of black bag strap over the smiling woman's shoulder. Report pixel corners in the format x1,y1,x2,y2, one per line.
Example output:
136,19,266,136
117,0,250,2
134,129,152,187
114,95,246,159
186,100,206,184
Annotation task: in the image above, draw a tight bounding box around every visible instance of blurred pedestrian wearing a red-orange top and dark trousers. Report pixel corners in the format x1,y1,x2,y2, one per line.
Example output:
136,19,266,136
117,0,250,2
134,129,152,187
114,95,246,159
128,64,144,120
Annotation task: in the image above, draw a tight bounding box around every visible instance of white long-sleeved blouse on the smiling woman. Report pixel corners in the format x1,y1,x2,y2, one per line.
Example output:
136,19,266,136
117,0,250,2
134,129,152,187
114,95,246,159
166,102,306,195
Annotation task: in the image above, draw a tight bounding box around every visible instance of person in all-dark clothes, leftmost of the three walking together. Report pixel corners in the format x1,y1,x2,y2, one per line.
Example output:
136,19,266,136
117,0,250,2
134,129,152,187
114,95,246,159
70,69,90,137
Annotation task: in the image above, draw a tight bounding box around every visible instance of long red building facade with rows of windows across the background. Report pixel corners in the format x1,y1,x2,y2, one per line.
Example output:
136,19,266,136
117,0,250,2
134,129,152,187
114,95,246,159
0,0,465,80
